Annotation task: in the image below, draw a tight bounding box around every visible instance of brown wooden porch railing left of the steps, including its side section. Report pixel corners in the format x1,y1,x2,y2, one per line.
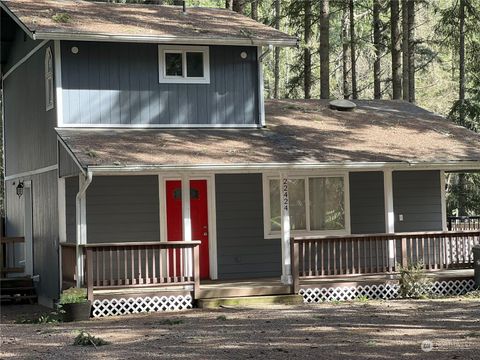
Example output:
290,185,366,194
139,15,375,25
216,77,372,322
62,241,200,300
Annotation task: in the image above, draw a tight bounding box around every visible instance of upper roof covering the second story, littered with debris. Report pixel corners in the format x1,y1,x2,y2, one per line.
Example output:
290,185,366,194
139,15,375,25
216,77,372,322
0,0,297,46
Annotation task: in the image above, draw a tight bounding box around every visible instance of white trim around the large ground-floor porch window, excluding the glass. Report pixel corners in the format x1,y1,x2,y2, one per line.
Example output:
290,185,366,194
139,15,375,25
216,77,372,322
263,172,351,239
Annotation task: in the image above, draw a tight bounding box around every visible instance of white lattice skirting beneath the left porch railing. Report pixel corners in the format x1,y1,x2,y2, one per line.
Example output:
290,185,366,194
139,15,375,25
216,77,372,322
92,295,193,318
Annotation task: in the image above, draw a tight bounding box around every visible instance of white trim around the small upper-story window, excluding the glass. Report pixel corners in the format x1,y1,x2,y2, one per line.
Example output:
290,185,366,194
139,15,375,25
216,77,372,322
158,45,210,84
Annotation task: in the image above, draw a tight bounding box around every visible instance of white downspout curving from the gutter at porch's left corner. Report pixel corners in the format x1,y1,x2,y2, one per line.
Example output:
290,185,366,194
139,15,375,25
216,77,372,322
76,170,93,287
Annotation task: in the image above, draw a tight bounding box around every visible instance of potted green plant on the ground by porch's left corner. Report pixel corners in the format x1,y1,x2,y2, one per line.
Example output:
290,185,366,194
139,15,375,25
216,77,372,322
59,288,92,322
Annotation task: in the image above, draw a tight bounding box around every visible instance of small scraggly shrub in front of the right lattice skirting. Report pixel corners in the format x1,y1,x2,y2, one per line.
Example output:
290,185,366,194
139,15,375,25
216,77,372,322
400,262,432,299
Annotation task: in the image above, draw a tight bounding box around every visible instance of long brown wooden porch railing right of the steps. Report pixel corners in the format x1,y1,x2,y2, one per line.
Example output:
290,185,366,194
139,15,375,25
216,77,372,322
291,230,480,288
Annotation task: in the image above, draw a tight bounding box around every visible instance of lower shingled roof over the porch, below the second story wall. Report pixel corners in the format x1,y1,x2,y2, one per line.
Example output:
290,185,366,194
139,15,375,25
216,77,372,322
57,100,480,169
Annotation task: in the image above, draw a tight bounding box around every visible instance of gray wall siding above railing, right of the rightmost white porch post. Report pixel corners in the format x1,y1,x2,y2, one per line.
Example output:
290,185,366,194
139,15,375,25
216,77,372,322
393,171,442,232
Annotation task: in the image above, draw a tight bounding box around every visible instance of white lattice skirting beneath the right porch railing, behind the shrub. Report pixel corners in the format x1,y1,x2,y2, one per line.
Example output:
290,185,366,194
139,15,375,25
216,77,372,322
299,279,475,303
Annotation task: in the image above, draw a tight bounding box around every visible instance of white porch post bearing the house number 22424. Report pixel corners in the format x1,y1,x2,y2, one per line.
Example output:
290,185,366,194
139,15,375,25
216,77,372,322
280,173,293,285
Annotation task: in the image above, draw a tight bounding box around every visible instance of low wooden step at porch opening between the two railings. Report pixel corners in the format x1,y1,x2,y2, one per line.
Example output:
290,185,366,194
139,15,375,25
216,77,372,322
197,295,303,309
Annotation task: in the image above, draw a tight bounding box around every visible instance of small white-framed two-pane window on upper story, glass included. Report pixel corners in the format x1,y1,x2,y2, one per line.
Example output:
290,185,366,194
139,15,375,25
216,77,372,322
158,45,210,84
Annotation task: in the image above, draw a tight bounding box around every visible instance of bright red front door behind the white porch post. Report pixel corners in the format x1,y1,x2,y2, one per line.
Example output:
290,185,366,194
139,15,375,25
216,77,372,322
165,180,210,279
